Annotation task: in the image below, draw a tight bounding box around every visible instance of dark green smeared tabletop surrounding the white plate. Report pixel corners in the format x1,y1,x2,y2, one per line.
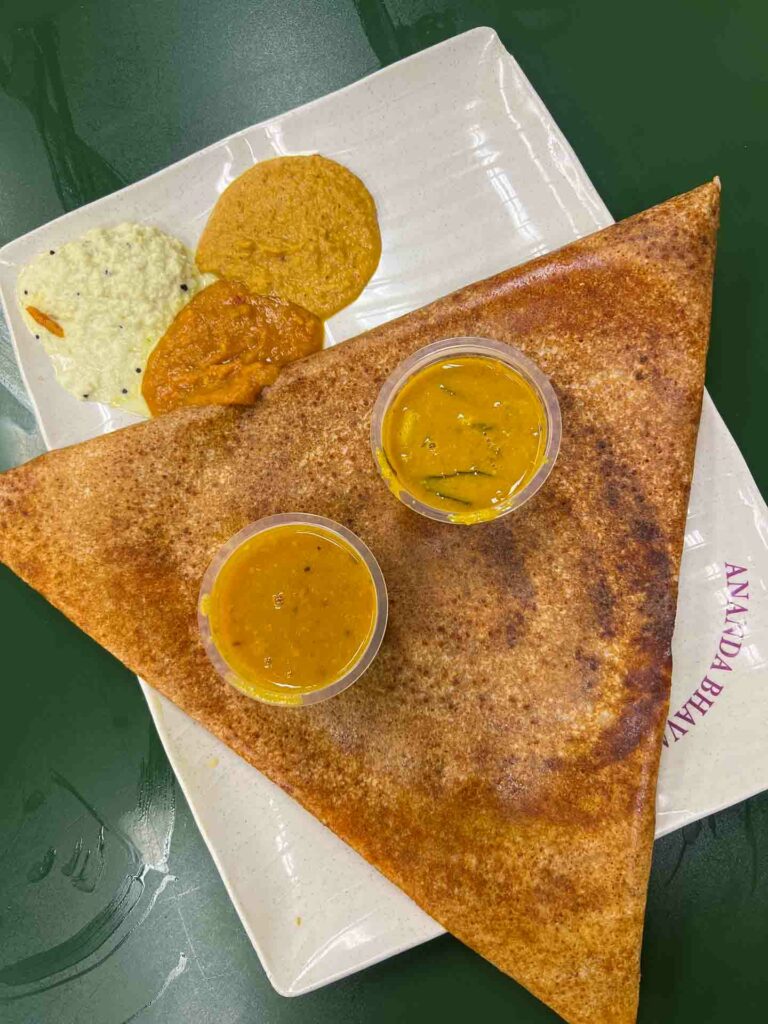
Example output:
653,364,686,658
0,0,768,1024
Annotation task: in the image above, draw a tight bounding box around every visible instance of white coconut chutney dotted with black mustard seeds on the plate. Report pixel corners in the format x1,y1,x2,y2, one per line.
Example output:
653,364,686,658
17,223,212,416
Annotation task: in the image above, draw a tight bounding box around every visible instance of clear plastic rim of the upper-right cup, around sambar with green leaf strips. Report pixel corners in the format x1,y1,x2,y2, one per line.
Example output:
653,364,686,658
371,337,562,525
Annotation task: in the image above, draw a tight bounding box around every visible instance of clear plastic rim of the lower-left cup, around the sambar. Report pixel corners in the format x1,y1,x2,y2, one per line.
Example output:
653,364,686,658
198,512,389,707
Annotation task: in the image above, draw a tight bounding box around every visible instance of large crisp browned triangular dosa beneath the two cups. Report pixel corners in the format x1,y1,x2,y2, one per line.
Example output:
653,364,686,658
0,184,719,1024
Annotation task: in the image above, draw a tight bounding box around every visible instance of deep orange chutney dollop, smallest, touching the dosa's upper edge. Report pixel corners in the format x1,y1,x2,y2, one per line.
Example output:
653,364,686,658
141,281,323,416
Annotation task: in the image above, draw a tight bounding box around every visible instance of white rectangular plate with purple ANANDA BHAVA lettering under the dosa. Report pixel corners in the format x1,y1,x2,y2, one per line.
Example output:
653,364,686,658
0,29,768,995
